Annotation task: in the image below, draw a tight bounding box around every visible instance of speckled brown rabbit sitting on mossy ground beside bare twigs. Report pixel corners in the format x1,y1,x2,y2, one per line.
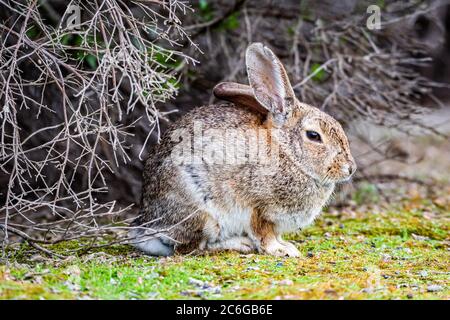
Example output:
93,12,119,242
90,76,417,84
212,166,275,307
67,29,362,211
130,43,356,257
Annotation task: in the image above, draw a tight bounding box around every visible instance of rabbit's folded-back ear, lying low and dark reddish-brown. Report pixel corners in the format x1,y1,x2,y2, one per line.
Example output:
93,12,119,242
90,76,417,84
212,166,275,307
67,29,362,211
213,82,268,115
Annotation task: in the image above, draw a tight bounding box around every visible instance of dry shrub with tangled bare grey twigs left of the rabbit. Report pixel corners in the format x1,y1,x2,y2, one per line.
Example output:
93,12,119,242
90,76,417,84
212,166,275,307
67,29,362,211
0,0,195,255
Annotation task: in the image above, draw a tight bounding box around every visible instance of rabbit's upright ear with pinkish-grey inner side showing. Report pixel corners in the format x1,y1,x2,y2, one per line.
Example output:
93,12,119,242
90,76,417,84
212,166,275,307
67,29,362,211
245,43,295,122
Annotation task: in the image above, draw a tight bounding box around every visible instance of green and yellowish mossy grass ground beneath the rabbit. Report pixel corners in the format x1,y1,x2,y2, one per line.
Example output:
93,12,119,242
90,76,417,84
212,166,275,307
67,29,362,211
0,200,450,299
